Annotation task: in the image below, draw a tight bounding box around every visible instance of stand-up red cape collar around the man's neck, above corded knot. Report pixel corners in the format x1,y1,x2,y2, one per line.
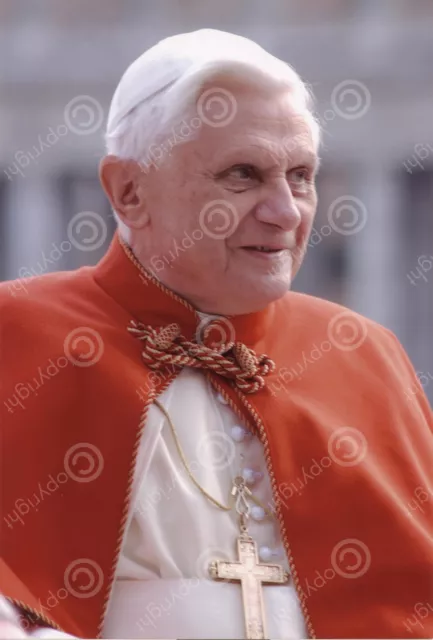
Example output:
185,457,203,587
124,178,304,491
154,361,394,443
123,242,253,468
93,231,276,349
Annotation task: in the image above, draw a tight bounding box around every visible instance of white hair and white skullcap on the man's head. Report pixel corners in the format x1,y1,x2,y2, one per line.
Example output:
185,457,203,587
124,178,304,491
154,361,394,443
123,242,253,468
105,29,320,233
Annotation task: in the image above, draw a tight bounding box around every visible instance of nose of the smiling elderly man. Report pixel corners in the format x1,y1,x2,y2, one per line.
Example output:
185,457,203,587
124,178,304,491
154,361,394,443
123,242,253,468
255,181,301,231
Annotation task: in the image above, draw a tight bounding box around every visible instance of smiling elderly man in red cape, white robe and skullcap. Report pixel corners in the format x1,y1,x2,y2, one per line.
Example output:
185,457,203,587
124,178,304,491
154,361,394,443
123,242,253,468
0,30,433,639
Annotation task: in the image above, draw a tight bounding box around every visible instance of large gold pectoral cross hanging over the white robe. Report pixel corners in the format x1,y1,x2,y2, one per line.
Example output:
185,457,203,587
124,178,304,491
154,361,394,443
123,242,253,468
209,478,289,640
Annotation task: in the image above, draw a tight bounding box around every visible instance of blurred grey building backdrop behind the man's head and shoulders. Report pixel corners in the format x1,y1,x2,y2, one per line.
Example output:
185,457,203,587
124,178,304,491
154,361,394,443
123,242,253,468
0,0,433,402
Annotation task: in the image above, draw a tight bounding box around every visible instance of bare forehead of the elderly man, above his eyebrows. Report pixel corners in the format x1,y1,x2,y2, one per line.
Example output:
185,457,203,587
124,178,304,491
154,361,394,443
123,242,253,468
191,88,317,158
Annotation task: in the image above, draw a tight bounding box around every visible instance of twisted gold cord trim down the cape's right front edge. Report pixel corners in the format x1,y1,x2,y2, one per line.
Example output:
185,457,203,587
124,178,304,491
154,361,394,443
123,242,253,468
207,374,317,640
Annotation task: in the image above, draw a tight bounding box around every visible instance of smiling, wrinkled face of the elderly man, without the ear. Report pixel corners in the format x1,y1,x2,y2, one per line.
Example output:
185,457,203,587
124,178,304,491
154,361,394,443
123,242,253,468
131,84,317,315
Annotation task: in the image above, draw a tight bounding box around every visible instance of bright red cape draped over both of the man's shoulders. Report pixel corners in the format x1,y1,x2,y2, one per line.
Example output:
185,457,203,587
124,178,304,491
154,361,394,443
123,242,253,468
0,236,433,638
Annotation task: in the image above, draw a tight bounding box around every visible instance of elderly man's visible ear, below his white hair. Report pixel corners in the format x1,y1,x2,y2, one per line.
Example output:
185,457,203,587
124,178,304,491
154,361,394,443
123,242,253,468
99,155,149,229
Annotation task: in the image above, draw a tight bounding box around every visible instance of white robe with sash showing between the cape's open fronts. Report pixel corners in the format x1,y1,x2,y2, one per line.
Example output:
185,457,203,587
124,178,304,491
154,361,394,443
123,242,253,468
103,369,308,640
